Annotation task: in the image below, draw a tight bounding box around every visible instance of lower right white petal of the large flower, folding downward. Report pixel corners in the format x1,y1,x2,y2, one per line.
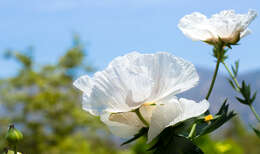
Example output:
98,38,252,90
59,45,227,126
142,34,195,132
147,99,209,143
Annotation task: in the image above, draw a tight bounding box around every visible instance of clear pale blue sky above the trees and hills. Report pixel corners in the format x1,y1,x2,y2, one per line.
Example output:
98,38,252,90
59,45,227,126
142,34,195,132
0,0,260,77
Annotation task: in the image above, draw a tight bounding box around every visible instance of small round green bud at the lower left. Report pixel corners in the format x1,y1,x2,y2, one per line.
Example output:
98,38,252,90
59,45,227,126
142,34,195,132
5,125,23,145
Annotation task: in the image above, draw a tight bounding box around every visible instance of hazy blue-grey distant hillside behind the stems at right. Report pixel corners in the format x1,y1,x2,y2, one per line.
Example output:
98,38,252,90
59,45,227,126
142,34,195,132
181,68,260,124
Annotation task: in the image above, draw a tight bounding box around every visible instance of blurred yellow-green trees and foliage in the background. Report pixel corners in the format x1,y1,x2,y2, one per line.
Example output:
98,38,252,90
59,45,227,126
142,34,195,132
0,37,260,154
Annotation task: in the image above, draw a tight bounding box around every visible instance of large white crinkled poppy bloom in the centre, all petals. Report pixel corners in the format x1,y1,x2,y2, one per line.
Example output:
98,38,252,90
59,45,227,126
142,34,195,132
74,52,209,142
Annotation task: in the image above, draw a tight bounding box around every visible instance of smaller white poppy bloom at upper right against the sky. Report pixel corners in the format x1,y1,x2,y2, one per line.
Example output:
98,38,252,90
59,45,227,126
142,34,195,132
178,10,257,44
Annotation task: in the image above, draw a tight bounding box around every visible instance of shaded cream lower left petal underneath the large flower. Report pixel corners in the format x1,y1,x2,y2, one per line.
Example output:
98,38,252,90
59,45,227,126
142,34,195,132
101,114,142,138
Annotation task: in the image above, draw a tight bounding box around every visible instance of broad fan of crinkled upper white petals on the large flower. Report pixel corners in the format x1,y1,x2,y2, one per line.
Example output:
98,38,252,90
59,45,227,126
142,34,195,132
74,52,199,115
